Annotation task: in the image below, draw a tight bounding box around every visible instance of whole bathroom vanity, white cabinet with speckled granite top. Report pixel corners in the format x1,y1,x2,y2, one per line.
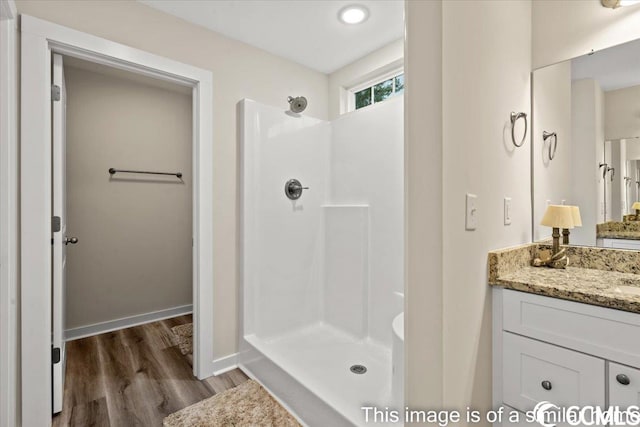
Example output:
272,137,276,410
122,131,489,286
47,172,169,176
489,244,640,425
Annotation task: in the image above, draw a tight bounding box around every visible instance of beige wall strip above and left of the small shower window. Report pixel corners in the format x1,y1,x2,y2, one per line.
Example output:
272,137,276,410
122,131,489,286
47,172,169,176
329,39,404,120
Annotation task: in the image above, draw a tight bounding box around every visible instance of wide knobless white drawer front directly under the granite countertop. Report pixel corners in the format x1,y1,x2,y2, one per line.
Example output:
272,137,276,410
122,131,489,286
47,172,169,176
502,290,640,366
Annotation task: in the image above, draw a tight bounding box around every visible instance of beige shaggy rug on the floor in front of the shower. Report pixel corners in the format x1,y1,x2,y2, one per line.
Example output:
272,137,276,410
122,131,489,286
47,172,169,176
163,380,300,427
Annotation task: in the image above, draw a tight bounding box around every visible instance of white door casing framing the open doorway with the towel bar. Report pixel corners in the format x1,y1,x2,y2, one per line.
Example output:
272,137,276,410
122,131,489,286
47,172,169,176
21,15,214,426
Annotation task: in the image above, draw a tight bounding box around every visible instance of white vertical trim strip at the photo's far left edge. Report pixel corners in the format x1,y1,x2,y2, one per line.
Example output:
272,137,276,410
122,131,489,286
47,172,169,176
0,0,19,427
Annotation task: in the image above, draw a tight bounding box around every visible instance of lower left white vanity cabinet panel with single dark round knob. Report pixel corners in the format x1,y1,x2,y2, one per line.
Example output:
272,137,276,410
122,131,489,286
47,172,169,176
502,332,605,412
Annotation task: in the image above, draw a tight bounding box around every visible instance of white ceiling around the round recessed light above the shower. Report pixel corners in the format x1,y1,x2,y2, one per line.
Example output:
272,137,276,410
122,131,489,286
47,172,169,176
138,0,404,73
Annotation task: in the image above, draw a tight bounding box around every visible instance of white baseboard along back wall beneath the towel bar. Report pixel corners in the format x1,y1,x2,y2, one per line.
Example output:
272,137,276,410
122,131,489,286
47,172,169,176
65,304,195,342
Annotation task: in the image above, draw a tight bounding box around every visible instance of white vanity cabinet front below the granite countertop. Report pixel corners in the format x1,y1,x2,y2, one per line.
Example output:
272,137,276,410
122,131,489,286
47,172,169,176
493,288,640,425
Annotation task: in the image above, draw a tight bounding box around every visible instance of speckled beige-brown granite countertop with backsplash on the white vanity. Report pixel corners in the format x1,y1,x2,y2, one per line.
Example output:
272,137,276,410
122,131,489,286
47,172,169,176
489,243,640,314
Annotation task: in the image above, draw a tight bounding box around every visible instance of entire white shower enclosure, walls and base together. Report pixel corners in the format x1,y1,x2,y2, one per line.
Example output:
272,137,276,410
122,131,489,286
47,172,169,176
239,96,404,426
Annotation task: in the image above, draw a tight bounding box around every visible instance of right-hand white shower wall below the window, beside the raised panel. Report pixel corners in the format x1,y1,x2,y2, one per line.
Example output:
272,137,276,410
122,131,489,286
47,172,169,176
327,96,404,347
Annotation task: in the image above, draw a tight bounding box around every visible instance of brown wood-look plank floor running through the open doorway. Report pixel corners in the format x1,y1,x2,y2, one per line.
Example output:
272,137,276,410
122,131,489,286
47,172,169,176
53,315,248,427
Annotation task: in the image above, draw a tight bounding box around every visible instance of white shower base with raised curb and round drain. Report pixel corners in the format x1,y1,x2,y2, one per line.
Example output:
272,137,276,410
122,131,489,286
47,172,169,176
240,323,397,426
